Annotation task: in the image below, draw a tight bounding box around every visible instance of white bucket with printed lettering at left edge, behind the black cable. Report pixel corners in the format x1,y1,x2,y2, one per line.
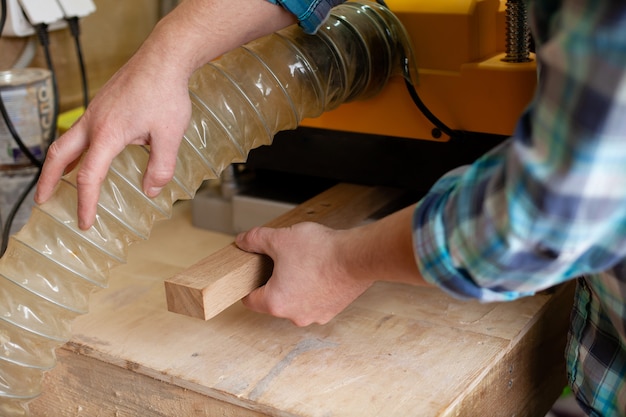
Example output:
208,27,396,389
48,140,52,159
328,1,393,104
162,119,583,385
0,68,54,168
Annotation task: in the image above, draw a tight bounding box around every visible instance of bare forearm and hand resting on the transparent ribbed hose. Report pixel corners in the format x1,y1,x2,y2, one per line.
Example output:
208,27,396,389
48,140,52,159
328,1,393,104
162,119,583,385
35,0,296,229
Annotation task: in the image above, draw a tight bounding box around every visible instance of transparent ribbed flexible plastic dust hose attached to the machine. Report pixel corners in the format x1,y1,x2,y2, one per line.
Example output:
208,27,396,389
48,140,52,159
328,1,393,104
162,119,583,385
0,2,410,417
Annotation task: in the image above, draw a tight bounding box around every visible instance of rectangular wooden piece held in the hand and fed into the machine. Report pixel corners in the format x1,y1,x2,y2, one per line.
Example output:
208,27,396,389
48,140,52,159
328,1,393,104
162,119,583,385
165,183,401,320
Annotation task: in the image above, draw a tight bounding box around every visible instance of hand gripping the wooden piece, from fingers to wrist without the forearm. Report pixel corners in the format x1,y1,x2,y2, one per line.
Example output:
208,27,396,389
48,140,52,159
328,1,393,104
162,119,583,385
236,223,373,326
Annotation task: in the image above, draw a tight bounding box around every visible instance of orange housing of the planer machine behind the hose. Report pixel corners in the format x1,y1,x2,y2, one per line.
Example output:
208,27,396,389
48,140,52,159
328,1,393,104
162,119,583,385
302,0,536,141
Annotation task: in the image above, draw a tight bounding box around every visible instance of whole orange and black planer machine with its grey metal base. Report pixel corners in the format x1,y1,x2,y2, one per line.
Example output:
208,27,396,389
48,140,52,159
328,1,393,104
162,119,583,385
192,0,537,233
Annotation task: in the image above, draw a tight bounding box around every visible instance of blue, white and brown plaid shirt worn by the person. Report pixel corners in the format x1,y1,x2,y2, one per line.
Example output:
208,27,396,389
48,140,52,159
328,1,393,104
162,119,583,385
269,0,626,416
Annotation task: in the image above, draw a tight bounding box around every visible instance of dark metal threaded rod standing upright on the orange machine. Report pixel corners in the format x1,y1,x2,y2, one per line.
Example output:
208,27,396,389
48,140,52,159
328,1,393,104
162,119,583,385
502,0,531,62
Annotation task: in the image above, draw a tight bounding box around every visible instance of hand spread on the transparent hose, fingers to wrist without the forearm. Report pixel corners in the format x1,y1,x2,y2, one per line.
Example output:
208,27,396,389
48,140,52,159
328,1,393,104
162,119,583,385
35,55,191,229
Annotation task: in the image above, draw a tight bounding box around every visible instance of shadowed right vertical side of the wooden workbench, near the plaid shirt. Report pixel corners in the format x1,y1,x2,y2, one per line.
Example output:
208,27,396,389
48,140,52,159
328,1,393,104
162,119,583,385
441,282,575,417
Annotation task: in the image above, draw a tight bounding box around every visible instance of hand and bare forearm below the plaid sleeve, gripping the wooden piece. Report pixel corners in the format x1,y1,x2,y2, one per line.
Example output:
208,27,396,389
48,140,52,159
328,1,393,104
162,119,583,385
235,207,424,326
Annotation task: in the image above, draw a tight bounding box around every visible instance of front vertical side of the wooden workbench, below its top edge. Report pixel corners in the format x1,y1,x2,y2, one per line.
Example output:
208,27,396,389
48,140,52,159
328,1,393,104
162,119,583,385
29,343,267,417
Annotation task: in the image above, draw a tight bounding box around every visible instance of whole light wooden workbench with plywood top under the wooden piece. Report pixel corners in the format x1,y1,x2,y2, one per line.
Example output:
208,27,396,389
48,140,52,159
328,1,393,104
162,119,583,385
31,202,571,417
